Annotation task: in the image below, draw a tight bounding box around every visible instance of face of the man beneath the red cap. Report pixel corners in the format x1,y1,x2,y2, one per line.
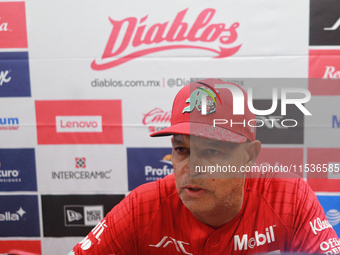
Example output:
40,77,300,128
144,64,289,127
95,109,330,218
172,135,249,222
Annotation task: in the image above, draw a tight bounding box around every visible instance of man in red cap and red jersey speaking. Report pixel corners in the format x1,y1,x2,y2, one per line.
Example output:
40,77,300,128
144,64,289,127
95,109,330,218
70,79,340,255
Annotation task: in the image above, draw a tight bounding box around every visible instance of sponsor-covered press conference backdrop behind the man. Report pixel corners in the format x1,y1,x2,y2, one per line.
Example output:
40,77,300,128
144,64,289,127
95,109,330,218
0,0,340,255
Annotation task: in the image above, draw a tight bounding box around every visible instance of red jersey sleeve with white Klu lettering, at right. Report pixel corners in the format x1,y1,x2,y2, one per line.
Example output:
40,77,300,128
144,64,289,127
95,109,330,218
290,179,340,254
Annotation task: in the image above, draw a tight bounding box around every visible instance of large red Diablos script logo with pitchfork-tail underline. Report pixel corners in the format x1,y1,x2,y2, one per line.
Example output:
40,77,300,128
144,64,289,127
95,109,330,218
91,8,242,70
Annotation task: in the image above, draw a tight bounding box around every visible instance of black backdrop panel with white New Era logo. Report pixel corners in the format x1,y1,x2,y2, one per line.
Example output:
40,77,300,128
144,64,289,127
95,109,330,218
41,195,125,237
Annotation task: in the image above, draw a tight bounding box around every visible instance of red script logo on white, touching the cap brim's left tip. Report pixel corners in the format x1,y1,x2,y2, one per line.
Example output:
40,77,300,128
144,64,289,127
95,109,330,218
142,107,171,132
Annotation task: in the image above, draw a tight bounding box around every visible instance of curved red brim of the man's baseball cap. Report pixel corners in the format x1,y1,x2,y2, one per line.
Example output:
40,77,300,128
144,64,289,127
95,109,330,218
150,122,247,143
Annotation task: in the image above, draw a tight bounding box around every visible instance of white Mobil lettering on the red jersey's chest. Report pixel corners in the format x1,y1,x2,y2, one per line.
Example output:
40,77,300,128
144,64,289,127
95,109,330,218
234,225,276,251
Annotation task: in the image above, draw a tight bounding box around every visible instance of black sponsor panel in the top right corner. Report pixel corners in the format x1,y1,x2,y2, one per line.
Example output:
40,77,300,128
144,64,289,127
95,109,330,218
309,0,340,45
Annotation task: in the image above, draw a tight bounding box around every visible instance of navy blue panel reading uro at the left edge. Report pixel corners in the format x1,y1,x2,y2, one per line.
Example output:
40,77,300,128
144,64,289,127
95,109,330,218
0,149,37,191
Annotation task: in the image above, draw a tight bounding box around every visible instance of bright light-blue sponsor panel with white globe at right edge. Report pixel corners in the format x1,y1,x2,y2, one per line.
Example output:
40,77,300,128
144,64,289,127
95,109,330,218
317,196,340,236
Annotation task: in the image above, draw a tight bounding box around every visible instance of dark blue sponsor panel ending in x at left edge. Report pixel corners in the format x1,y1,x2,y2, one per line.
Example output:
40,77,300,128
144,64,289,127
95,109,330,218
0,52,31,97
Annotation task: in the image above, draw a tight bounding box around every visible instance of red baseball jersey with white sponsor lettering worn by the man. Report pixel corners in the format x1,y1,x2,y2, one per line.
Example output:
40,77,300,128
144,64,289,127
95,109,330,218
73,175,340,255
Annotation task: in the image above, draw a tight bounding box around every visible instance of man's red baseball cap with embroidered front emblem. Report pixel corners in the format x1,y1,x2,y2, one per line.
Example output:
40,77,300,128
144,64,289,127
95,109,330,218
150,79,256,143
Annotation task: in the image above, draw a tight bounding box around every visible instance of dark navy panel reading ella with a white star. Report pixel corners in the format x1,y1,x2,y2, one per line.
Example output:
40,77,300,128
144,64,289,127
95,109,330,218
0,195,40,237
